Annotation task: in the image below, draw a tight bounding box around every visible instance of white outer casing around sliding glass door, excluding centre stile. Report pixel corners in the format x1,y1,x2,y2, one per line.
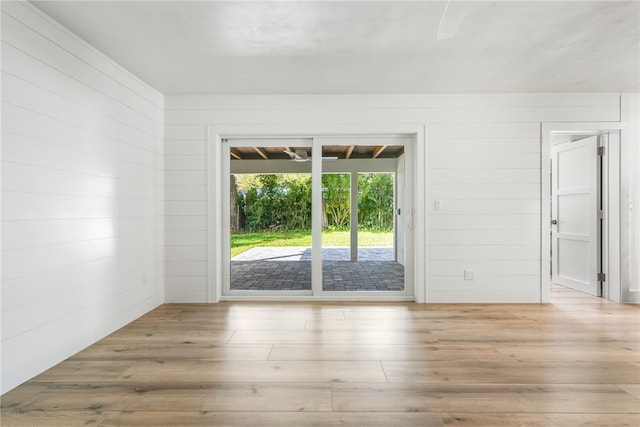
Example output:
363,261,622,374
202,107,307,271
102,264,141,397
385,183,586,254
207,124,427,302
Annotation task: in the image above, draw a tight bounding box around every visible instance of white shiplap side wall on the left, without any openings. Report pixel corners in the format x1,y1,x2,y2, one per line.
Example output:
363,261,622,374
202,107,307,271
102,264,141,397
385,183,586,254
1,2,164,392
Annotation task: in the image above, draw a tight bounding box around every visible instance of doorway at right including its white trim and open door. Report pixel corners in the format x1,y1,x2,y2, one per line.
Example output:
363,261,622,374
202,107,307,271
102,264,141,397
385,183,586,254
541,123,620,302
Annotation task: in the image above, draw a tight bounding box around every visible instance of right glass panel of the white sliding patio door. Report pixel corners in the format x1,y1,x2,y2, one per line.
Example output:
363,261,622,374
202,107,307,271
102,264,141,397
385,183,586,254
322,144,405,292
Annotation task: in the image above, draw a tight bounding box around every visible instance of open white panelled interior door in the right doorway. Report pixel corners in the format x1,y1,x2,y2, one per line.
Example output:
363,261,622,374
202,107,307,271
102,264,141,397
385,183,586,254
551,136,601,296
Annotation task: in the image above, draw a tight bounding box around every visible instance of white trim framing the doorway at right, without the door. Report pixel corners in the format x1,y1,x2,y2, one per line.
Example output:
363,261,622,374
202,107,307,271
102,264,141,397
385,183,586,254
540,122,625,303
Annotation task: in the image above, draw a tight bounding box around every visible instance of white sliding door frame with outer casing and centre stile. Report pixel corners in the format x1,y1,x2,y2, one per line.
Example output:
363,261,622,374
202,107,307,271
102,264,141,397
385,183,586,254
207,124,427,302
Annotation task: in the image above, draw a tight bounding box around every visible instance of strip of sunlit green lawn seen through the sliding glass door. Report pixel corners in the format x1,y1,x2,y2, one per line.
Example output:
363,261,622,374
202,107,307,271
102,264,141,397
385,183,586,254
231,230,393,257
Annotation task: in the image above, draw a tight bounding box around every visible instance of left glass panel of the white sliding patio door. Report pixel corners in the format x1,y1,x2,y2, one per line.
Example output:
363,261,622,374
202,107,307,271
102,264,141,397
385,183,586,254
228,140,312,294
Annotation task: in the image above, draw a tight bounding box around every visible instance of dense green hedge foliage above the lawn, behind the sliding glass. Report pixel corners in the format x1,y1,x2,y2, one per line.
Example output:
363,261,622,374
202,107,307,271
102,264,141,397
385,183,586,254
232,173,394,232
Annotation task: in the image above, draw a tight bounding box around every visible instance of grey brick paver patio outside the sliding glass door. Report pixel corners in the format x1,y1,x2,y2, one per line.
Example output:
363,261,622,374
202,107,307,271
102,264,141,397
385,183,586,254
231,246,404,292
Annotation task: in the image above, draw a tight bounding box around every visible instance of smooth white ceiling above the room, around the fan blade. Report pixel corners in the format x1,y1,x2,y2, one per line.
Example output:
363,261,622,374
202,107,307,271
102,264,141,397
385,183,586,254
33,0,640,94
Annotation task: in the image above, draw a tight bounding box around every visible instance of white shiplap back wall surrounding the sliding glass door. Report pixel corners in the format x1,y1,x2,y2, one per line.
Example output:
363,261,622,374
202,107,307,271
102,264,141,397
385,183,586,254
165,94,620,302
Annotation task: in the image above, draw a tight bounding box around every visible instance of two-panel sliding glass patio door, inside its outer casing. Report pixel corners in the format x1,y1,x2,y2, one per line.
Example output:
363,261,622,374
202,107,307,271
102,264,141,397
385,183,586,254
221,137,413,299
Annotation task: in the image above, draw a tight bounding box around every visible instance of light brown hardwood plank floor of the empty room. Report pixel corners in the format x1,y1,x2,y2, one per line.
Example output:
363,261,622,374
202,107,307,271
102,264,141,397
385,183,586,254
1,288,640,427
